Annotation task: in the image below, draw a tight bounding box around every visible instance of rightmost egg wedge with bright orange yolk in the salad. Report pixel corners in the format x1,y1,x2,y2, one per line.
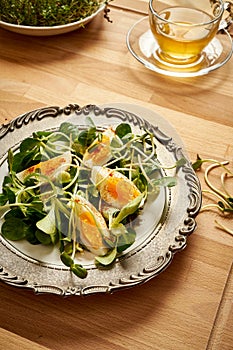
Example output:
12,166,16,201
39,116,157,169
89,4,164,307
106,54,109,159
91,166,141,209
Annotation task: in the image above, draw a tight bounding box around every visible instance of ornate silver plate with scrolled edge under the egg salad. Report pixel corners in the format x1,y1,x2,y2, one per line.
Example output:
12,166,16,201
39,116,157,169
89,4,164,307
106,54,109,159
0,105,201,296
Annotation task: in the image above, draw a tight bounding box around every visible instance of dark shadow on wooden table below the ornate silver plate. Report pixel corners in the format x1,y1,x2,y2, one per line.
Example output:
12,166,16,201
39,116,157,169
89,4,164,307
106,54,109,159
0,242,193,350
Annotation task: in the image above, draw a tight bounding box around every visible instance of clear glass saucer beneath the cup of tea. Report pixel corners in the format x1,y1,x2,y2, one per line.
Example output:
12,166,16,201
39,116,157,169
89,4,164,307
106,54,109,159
126,16,233,77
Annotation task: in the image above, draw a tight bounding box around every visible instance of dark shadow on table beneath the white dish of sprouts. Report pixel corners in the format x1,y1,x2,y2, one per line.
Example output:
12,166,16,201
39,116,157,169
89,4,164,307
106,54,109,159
0,14,104,65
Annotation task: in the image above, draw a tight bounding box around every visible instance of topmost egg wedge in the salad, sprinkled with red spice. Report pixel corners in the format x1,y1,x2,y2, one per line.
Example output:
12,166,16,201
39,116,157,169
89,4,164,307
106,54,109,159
83,128,115,168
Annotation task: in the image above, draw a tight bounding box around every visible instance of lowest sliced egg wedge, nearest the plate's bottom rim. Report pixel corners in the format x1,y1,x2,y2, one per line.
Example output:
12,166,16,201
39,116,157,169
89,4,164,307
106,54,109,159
73,195,110,256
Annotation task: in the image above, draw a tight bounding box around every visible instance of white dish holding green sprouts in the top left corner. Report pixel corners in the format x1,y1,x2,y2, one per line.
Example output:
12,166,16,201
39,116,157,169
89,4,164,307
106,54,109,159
0,4,105,36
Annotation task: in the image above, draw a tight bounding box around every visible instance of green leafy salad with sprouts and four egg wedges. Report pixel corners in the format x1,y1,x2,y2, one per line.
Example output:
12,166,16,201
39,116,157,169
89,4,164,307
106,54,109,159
0,117,185,278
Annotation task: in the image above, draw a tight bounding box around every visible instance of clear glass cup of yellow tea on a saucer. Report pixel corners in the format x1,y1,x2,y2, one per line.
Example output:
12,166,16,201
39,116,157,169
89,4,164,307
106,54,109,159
149,0,230,66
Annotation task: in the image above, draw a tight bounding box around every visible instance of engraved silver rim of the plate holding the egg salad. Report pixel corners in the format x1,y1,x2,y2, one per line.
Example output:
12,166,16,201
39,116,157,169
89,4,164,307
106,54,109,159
0,104,201,296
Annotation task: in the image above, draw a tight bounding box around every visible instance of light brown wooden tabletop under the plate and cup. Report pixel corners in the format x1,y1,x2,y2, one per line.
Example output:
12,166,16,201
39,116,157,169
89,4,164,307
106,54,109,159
0,0,233,350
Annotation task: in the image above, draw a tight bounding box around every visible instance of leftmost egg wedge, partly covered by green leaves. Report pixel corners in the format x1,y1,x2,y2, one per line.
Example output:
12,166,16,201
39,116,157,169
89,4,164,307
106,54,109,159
17,151,72,182
